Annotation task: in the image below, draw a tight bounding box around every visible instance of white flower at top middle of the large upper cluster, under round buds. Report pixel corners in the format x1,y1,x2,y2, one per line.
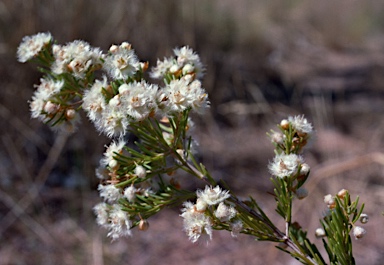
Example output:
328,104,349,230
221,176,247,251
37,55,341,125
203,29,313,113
103,42,140,79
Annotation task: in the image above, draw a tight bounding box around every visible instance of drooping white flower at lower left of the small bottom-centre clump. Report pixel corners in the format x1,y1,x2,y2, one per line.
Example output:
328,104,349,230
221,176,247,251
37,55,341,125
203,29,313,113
180,202,212,243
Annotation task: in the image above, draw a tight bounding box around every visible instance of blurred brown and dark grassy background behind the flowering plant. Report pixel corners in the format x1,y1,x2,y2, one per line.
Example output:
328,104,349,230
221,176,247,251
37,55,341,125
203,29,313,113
0,0,384,265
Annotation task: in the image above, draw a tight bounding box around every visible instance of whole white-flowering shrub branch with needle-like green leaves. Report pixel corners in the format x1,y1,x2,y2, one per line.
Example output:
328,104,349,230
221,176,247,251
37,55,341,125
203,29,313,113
17,33,368,264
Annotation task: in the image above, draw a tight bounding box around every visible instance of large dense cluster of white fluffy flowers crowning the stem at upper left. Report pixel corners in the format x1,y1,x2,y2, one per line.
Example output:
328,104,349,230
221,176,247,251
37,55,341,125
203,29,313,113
17,33,209,137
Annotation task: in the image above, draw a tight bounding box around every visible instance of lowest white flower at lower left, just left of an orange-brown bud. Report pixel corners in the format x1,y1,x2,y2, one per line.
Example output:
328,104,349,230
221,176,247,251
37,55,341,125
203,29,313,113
108,204,132,241
